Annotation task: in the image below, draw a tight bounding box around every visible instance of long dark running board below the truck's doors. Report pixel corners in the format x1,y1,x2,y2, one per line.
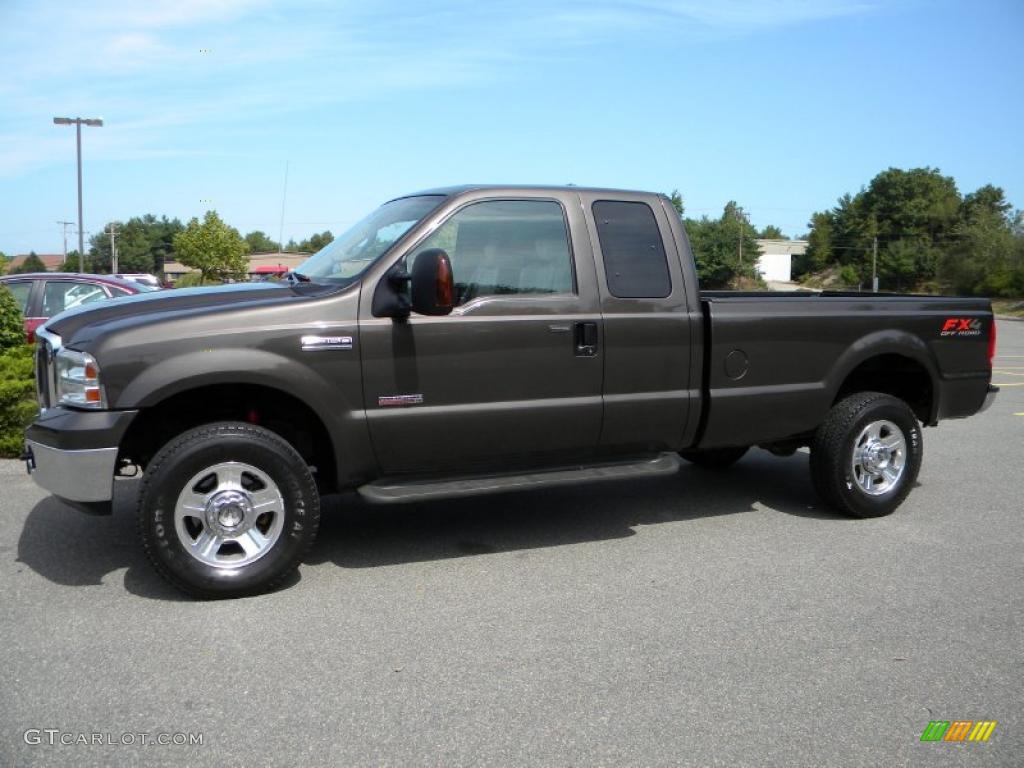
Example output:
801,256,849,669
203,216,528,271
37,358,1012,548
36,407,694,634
356,454,681,504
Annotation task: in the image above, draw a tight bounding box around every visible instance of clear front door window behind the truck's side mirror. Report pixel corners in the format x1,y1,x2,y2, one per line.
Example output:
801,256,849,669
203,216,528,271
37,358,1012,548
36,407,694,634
410,200,574,304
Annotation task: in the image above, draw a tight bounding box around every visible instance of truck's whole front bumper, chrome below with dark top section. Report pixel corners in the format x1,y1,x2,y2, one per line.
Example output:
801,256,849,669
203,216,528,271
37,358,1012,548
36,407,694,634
25,408,138,514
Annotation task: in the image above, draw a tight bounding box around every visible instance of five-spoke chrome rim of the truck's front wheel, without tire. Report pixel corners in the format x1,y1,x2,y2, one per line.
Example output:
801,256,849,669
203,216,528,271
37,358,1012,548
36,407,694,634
174,462,285,568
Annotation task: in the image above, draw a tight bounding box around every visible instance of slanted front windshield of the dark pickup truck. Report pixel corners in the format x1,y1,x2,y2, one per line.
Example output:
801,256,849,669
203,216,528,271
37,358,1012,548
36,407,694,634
295,195,444,283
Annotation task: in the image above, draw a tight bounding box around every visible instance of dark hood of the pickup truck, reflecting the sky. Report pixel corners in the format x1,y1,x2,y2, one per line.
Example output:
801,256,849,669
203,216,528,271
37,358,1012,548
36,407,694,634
45,283,339,344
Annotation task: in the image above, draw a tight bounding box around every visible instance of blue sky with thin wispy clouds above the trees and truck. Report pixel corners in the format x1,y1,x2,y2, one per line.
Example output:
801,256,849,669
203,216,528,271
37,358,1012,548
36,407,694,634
0,0,1024,255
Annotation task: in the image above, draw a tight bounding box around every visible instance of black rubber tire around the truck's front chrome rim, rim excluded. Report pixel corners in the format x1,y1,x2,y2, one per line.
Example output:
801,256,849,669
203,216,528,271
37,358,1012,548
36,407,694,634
141,429,318,596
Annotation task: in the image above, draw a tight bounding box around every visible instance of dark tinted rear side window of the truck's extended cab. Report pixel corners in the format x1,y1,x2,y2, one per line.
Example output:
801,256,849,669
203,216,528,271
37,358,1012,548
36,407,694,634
591,200,672,299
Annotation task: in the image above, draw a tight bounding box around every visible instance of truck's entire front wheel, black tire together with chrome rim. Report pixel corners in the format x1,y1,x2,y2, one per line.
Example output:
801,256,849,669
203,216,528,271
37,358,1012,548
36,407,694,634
137,422,319,598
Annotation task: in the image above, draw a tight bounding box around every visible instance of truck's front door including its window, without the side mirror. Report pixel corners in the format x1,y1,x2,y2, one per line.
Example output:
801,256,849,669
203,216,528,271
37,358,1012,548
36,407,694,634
359,193,602,473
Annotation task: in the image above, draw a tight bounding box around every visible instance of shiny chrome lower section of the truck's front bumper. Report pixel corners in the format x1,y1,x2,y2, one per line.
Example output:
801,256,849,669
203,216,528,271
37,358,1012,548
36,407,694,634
25,440,118,502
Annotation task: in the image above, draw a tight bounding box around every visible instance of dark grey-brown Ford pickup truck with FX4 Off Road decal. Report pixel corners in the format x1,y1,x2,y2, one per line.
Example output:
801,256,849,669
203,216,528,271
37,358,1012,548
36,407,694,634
26,186,996,597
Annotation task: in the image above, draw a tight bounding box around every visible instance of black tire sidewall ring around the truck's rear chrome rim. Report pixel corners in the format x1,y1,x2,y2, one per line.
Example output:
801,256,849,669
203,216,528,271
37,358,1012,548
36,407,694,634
839,397,924,517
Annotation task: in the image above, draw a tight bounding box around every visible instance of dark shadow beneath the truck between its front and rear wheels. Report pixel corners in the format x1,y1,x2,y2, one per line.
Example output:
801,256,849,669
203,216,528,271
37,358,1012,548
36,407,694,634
306,452,848,568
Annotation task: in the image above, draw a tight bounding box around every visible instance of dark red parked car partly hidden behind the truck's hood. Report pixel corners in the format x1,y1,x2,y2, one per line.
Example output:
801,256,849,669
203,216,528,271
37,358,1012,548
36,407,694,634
0,272,156,344
